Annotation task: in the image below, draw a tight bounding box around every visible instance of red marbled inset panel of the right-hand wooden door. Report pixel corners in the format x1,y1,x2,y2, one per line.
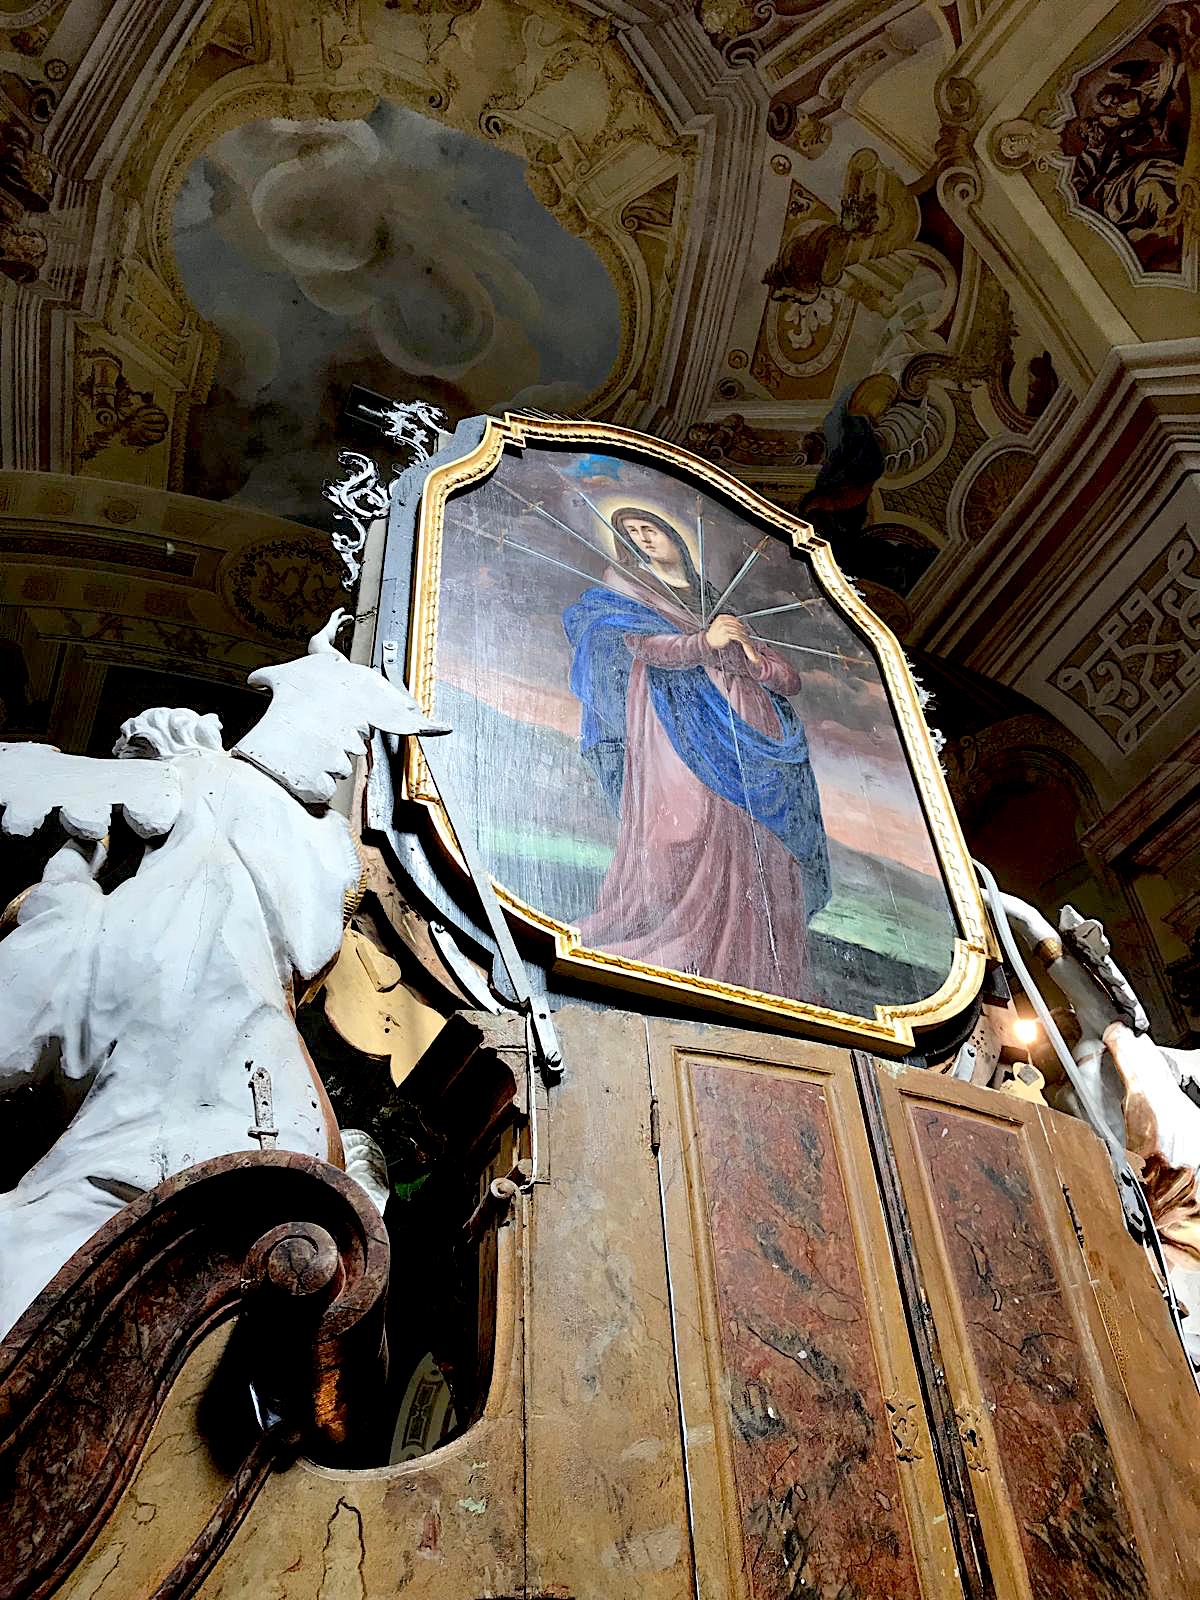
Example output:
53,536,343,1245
910,1106,1150,1600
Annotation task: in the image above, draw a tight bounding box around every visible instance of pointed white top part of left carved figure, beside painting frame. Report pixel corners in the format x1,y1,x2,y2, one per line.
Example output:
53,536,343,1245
234,613,448,805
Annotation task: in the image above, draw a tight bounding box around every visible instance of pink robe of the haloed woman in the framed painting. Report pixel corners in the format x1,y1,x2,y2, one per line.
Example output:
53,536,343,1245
579,568,813,1000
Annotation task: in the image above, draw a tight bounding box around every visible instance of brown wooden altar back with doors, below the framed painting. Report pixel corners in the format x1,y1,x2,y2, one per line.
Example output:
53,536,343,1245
51,1008,1200,1600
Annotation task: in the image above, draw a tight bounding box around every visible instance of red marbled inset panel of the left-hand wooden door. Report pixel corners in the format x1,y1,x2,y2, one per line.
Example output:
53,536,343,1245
691,1066,922,1600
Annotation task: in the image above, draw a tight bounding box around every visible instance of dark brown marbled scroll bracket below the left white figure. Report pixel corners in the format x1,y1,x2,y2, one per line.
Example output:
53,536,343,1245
0,1150,389,1600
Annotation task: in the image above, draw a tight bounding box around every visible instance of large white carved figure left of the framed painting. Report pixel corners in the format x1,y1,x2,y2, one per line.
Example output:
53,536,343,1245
0,611,445,1334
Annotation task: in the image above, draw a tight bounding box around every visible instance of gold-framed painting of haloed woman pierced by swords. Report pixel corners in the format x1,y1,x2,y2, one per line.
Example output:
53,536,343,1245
408,416,984,1048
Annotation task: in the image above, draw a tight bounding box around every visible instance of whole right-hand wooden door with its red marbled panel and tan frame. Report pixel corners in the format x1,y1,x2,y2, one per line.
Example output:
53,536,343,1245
877,1066,1200,1600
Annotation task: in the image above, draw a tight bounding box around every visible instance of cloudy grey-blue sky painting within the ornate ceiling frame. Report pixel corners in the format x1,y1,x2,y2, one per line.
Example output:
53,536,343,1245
174,102,621,520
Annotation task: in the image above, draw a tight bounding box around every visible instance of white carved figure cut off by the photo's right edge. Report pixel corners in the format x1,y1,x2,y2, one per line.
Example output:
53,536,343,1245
1002,894,1200,1365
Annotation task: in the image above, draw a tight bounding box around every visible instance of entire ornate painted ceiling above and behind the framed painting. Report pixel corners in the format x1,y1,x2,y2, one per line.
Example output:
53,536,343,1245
0,0,1200,1036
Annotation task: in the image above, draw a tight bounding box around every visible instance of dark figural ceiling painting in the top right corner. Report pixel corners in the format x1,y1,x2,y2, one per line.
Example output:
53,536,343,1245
1053,0,1200,288
